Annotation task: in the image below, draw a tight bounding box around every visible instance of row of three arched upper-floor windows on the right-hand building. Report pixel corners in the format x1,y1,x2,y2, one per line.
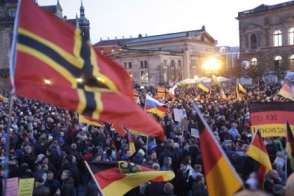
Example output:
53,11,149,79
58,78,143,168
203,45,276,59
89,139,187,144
250,27,294,49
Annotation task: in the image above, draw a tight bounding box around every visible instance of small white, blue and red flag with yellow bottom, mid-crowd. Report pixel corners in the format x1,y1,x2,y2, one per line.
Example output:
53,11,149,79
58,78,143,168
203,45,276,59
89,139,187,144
145,95,168,117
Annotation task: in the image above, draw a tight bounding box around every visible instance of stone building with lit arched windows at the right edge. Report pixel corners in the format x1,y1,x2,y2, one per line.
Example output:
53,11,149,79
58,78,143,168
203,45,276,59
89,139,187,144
236,1,294,74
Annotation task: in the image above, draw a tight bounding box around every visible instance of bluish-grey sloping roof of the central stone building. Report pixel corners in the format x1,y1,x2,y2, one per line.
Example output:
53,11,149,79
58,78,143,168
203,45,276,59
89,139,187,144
128,29,204,44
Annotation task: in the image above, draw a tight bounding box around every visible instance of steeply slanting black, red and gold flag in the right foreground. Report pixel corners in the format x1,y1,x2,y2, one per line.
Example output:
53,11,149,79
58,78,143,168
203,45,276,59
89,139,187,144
193,103,242,196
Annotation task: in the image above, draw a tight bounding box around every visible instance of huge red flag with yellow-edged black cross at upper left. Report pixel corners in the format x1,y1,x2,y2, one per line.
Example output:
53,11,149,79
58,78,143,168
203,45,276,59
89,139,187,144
10,0,164,140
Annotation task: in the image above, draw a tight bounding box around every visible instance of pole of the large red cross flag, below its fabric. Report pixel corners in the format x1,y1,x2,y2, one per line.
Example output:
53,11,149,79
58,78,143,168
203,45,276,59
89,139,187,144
4,93,13,195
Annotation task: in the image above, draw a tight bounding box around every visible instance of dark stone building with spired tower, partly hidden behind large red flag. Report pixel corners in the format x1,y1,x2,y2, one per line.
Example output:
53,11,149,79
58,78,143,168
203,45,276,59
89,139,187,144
0,0,90,90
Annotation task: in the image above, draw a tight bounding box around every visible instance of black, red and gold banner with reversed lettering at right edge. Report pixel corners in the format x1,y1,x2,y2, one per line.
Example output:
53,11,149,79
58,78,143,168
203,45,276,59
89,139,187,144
249,102,294,137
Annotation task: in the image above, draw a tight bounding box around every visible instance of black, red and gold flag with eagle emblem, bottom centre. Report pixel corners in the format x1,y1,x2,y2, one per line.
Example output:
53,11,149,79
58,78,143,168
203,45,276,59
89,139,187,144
86,161,175,196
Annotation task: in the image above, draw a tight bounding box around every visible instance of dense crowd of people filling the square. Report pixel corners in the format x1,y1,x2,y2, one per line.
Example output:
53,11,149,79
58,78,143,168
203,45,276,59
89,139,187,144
0,81,294,196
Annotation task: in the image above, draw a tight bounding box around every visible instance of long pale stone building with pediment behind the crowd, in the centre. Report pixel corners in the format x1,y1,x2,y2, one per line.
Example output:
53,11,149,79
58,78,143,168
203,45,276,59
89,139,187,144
95,26,217,85
